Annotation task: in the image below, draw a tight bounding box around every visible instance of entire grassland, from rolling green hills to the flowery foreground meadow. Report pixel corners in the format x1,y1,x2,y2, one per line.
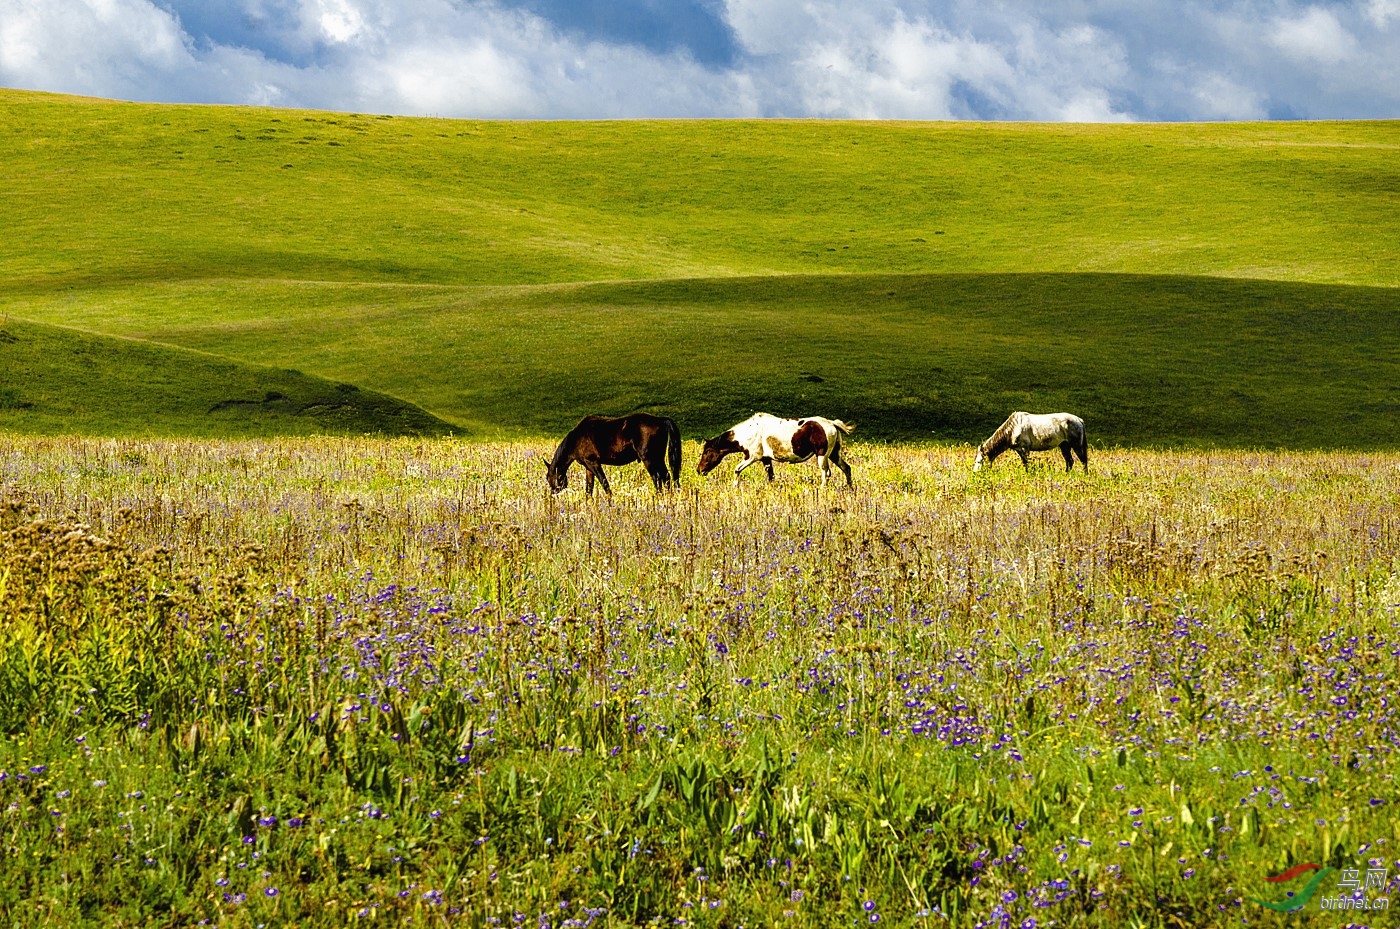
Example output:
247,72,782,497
0,90,1400,929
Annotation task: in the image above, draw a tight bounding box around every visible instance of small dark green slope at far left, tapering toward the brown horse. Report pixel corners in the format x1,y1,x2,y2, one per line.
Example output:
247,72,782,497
0,320,451,437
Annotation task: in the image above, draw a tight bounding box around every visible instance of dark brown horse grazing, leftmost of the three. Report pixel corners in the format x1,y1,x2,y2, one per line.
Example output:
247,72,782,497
547,413,680,497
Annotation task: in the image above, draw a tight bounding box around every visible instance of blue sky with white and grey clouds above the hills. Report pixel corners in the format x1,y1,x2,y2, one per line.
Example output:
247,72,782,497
0,0,1400,122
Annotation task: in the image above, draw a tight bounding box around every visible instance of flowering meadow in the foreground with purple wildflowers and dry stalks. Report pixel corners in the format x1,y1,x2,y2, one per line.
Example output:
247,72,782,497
0,437,1400,929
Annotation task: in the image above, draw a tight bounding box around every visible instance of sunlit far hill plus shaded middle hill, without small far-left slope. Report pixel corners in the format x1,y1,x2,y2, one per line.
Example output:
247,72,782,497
0,91,1400,446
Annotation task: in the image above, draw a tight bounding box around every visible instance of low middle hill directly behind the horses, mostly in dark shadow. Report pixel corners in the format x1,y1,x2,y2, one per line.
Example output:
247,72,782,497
5,274,1400,448
